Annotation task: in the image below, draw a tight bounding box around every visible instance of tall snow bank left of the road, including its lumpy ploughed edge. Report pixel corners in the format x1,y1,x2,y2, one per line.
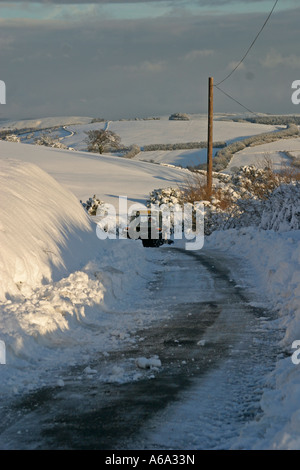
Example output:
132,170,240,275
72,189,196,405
0,160,156,394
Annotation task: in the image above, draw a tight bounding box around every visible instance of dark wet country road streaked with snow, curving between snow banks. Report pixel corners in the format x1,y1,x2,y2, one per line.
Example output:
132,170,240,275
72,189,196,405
0,248,280,450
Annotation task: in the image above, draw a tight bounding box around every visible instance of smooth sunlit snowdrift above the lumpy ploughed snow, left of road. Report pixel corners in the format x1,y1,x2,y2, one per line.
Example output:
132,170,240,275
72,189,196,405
0,159,153,302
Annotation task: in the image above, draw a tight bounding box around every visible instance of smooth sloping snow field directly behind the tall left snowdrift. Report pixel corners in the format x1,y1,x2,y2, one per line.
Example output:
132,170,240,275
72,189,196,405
0,141,185,207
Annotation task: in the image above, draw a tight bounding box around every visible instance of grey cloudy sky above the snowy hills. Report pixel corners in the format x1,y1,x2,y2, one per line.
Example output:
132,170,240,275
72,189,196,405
0,0,300,119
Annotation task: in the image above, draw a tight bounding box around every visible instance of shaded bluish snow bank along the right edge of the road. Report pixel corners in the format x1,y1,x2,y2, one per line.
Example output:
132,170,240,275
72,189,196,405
205,227,300,449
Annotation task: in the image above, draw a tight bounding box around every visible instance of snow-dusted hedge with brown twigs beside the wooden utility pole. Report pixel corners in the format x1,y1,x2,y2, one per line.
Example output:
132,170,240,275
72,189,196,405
148,165,300,235
